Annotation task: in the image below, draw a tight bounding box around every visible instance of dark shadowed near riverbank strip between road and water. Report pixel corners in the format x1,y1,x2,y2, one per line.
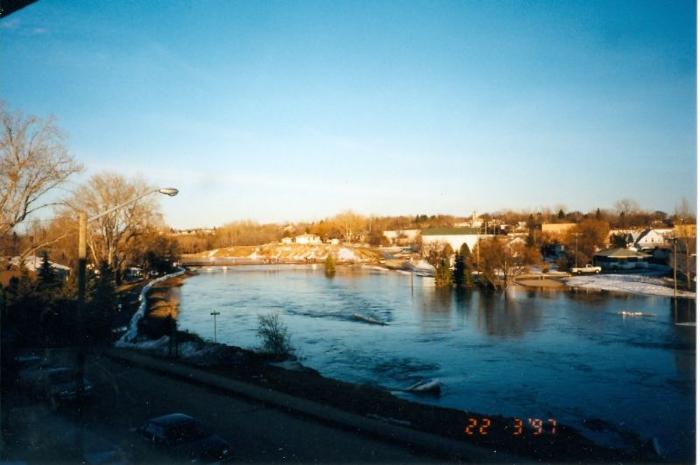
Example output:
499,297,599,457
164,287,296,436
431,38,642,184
117,268,659,461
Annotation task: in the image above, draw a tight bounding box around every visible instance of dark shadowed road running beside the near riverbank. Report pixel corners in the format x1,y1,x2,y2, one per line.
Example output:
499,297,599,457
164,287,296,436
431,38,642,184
5,357,438,463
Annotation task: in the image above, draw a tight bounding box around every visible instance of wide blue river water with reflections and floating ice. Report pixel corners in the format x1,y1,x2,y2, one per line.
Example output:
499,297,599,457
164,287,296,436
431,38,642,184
179,266,695,460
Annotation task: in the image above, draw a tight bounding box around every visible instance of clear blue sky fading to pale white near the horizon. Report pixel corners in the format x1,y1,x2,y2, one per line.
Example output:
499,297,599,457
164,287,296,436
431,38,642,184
0,0,697,227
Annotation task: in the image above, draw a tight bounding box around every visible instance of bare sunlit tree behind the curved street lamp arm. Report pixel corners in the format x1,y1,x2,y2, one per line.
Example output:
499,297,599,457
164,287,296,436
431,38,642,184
66,173,162,275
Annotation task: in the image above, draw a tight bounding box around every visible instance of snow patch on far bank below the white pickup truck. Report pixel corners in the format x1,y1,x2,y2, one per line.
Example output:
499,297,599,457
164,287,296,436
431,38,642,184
565,274,695,299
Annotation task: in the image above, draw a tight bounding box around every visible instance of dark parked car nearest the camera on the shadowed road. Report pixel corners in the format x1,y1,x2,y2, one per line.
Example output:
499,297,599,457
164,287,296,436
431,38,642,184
138,413,232,463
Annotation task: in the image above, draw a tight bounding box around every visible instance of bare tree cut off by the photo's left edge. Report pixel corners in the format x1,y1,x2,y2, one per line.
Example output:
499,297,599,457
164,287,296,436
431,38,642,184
0,102,82,236
